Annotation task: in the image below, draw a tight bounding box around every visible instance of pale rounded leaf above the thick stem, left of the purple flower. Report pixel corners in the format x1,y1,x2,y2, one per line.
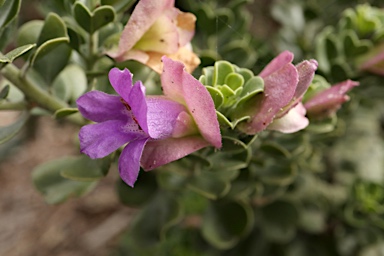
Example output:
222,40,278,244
52,64,87,102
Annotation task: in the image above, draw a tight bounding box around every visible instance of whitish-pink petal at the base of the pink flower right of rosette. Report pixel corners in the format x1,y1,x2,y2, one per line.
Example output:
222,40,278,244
267,103,309,133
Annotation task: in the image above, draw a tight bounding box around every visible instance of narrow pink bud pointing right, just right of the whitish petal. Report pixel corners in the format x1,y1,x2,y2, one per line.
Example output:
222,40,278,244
304,80,359,119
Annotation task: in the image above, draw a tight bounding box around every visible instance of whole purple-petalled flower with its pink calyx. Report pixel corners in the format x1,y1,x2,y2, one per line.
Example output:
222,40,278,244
77,58,221,186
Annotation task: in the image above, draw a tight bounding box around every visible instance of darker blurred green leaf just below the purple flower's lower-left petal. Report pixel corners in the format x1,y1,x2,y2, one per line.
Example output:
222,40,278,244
60,155,111,181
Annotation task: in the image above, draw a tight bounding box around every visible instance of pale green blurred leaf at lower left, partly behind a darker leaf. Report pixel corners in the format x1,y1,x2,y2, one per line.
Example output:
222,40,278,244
32,157,97,204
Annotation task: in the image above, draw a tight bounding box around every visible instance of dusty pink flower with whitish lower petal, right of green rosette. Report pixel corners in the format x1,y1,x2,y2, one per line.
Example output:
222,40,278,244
239,51,317,134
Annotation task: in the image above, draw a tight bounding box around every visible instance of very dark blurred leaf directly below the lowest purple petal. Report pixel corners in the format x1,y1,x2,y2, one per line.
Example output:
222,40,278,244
116,171,158,207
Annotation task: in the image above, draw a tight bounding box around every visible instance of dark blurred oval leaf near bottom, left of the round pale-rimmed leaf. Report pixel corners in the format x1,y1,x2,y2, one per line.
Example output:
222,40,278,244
130,192,183,248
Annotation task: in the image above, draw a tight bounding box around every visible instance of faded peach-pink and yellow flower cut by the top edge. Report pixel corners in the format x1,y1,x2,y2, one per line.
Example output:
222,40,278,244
107,0,200,73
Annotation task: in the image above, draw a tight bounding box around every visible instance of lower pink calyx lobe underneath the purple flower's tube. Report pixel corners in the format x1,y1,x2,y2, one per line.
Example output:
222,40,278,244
141,136,209,170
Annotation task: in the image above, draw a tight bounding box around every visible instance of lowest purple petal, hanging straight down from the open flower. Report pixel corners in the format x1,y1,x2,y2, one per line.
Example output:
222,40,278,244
119,138,148,187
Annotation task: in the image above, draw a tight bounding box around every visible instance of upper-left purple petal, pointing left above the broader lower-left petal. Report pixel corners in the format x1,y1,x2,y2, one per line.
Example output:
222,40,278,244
76,91,128,122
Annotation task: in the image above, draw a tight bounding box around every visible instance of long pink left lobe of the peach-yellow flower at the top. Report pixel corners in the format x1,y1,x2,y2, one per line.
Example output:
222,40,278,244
114,0,175,55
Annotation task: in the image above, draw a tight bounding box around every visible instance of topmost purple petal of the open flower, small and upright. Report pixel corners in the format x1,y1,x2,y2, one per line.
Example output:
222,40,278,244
108,68,132,103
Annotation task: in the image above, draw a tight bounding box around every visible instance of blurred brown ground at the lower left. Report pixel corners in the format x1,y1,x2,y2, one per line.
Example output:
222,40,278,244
0,112,133,256
